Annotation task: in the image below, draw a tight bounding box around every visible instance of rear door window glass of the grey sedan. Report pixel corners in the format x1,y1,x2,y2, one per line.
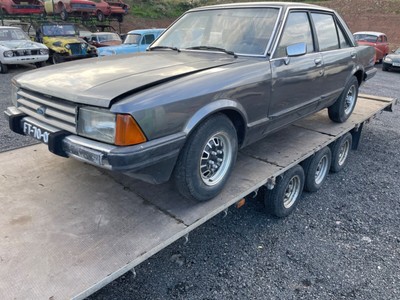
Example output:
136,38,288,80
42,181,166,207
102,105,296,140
311,13,339,51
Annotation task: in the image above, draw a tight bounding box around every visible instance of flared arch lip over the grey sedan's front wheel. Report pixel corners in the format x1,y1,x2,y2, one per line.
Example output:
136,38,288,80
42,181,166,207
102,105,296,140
183,100,247,147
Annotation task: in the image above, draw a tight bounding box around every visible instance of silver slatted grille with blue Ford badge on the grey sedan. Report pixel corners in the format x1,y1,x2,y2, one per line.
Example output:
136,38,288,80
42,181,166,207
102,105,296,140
17,89,78,133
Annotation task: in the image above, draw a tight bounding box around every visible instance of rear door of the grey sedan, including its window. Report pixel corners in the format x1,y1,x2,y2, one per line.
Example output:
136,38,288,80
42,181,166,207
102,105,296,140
311,12,357,107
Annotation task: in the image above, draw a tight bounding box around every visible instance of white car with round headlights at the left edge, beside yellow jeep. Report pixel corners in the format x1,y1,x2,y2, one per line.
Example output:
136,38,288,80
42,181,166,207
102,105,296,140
0,26,49,73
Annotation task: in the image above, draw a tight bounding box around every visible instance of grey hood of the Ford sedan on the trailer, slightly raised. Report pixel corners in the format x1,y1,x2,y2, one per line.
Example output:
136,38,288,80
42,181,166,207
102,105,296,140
15,51,238,107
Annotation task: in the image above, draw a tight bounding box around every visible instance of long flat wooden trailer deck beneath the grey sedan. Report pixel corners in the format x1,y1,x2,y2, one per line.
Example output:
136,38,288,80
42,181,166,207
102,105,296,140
0,95,396,300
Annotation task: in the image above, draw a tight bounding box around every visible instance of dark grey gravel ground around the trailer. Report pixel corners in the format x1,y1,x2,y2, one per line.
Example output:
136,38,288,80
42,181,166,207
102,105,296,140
0,65,400,300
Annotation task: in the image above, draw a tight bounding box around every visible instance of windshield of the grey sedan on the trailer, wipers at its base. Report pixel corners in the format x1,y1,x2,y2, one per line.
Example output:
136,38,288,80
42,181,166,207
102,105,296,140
153,8,279,55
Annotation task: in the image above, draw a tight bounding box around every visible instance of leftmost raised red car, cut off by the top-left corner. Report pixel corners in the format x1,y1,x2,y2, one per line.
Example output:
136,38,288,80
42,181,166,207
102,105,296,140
0,0,44,15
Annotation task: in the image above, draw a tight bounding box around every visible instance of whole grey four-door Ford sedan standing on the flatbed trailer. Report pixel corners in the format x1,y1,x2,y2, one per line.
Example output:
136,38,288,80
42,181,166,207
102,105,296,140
5,2,376,201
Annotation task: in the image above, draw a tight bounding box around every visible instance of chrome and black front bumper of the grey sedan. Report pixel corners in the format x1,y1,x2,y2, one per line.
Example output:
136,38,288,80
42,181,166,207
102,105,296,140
4,107,186,184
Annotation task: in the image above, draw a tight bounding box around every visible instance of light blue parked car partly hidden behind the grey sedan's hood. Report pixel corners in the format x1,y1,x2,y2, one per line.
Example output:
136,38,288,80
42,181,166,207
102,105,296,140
98,29,165,56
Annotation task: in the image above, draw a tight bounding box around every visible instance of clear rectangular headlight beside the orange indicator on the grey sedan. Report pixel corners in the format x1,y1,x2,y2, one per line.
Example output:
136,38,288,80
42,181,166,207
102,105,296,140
78,107,116,144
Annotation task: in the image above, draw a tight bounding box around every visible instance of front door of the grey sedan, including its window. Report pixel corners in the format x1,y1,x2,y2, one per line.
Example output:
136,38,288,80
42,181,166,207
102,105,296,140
269,11,324,129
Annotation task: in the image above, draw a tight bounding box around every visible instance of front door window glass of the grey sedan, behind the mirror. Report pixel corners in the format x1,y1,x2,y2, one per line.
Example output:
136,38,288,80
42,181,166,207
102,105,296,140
275,12,314,57
